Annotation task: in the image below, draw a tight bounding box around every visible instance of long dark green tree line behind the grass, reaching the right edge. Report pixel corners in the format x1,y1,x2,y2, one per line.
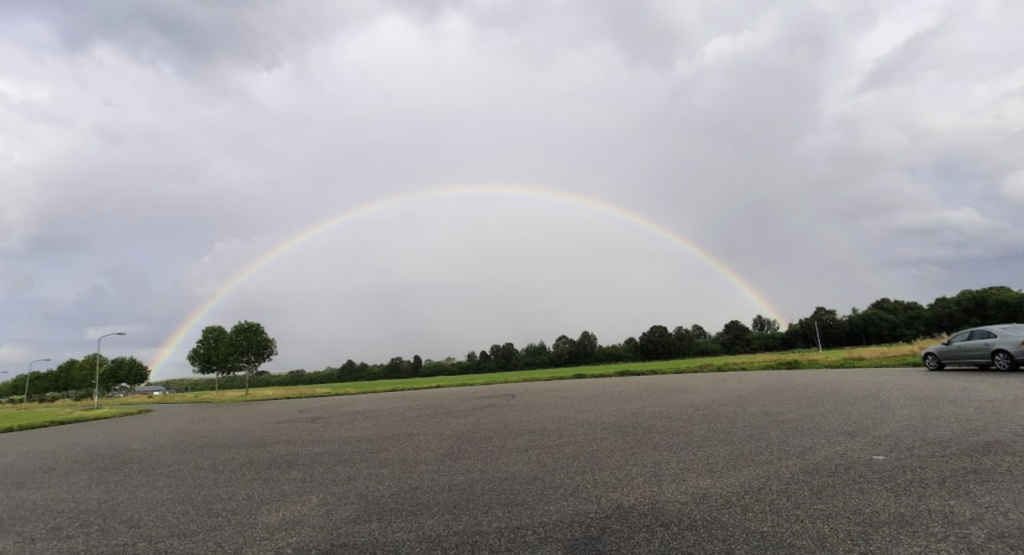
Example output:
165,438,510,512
153,287,1024,390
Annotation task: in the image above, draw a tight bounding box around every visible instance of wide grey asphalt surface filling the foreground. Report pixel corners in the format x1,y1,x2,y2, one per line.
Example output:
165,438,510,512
0,370,1024,555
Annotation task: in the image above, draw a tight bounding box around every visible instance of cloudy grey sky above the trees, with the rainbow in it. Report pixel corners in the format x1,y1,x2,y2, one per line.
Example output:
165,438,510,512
0,0,1024,379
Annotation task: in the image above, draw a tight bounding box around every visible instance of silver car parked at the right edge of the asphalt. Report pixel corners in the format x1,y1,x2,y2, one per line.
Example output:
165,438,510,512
921,324,1024,370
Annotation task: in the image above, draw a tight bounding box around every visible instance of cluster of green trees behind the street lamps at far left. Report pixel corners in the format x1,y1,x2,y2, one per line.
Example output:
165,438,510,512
0,353,150,401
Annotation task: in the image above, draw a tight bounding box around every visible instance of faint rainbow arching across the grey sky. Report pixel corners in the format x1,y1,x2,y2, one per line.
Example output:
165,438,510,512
150,185,787,376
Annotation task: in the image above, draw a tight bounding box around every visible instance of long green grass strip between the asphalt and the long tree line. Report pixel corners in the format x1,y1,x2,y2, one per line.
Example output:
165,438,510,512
83,340,934,405
